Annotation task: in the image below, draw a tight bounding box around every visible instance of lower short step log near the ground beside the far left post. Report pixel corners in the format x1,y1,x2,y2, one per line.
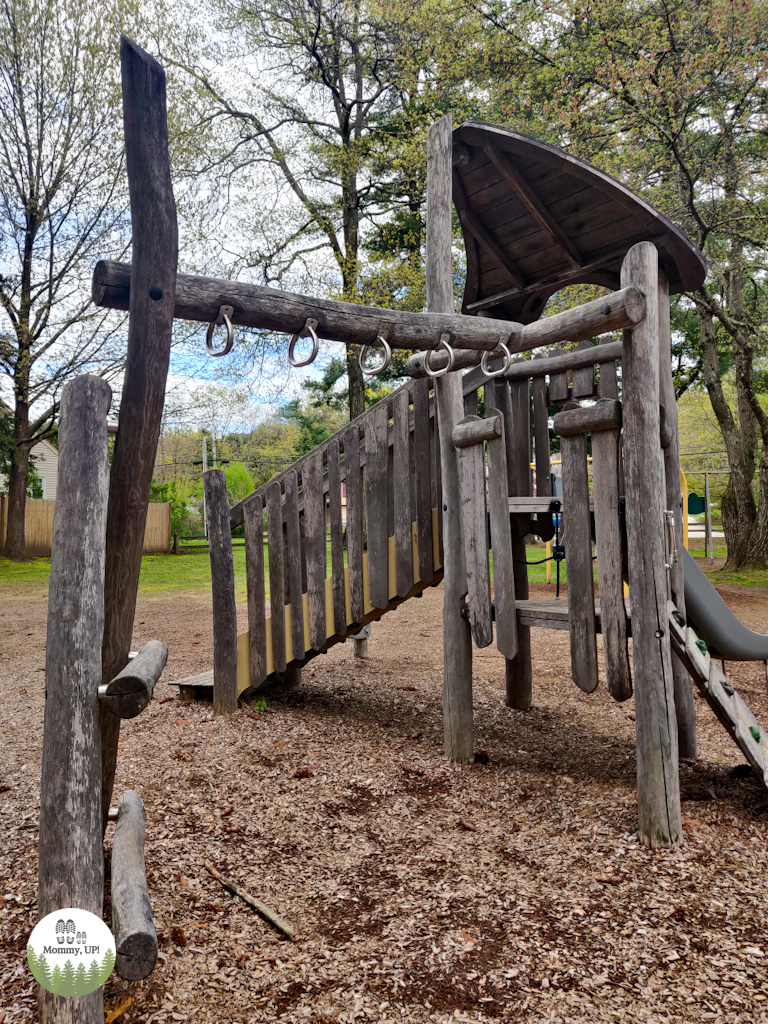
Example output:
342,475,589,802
112,791,158,981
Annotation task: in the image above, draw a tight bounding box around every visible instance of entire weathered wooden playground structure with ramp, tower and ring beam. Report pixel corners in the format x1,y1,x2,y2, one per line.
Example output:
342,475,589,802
40,39,768,1022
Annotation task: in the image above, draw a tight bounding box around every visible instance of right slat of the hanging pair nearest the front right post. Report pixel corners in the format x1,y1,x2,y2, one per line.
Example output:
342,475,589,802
593,413,632,700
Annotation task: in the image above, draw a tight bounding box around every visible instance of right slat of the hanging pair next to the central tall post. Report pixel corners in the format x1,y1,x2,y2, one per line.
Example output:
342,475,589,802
485,411,517,660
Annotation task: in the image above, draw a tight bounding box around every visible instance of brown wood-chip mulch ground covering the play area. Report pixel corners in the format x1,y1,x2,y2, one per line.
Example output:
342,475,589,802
0,587,768,1024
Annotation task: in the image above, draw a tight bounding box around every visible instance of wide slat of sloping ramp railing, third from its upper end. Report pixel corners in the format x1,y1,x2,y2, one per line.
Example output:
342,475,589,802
366,401,389,608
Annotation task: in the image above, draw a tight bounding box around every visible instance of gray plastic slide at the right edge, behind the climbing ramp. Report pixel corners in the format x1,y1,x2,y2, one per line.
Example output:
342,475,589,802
683,548,768,662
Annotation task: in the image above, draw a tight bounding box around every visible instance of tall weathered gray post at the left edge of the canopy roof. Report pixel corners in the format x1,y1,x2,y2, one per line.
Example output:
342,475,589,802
427,114,474,761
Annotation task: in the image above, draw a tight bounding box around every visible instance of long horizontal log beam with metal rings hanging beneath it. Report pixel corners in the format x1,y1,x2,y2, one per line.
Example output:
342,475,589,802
91,260,522,352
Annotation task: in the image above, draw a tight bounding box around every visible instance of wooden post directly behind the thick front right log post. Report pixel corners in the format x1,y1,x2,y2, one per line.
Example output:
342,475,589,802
658,268,697,758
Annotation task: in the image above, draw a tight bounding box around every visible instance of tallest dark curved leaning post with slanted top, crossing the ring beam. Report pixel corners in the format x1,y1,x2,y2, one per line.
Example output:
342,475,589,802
101,36,178,827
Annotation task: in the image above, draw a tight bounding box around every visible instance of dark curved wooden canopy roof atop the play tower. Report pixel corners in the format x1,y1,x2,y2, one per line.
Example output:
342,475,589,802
454,121,707,324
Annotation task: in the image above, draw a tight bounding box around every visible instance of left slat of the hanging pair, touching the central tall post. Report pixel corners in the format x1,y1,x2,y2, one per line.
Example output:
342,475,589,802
459,416,493,647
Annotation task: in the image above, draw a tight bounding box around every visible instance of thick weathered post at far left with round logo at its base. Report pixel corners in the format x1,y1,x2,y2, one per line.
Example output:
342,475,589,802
38,376,112,1024
